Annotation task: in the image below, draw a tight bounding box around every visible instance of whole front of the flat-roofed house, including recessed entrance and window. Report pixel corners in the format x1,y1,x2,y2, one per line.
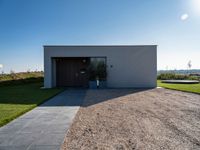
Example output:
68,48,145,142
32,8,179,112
44,45,157,88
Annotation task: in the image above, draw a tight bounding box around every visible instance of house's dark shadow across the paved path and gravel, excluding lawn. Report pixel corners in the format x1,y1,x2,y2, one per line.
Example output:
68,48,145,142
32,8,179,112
39,89,150,107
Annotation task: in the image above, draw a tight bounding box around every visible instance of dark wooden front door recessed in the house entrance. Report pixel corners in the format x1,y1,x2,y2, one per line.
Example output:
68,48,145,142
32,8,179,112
56,58,89,87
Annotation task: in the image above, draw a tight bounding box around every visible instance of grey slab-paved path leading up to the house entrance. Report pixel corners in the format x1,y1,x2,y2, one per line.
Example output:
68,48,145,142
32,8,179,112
0,90,85,150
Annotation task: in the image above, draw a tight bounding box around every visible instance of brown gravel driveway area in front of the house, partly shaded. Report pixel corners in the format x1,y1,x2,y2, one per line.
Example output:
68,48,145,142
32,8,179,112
62,88,200,150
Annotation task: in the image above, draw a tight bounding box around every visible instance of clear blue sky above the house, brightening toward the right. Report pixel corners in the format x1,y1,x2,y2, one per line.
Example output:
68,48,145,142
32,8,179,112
0,0,200,72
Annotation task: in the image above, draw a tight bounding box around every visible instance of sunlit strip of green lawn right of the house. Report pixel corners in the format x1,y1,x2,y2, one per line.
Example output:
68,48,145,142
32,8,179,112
157,80,200,94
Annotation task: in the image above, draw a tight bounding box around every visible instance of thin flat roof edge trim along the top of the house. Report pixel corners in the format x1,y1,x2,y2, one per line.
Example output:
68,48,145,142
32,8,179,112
43,45,158,47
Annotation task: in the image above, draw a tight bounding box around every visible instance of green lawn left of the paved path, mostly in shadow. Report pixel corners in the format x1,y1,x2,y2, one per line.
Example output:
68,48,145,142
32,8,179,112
0,82,62,126
